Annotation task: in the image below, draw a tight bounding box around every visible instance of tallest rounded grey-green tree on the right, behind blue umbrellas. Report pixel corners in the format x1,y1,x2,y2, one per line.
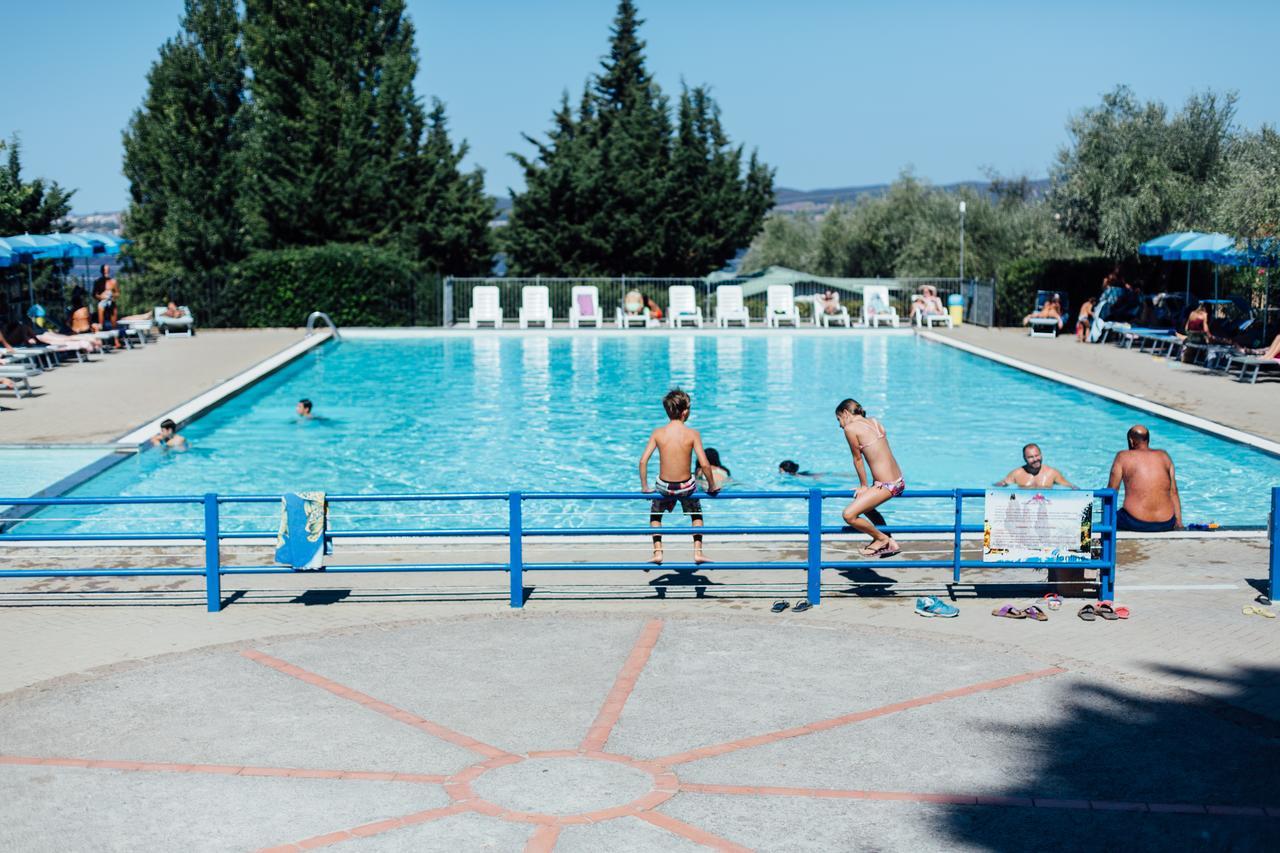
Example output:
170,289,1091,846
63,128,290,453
1050,86,1235,259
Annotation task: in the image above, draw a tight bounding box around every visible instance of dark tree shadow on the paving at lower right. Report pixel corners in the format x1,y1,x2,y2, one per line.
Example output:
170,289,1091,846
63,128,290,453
938,667,1280,850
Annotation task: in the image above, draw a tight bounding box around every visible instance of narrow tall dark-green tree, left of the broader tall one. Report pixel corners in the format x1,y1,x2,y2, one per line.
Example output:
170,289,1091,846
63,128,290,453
124,0,244,302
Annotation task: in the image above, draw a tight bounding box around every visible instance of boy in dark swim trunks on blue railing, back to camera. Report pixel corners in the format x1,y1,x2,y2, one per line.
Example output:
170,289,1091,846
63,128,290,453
640,388,719,563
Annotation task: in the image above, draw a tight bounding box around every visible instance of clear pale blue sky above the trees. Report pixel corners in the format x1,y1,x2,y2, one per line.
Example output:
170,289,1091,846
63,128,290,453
0,0,1280,213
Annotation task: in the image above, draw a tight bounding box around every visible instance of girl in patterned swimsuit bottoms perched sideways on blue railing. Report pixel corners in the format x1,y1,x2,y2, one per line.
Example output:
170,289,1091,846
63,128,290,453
836,400,906,557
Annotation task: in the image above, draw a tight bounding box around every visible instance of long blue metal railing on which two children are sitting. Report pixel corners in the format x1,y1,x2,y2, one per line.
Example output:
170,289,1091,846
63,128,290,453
0,489,1116,612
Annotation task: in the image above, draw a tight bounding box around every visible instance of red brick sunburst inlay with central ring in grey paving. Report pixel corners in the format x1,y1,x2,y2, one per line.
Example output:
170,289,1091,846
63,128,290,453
0,620,1280,853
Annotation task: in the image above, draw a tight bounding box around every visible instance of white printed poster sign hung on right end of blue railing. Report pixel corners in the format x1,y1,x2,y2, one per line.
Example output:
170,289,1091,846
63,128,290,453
982,489,1093,562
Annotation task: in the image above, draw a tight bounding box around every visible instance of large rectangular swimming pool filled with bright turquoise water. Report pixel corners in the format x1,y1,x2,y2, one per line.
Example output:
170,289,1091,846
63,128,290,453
10,332,1280,533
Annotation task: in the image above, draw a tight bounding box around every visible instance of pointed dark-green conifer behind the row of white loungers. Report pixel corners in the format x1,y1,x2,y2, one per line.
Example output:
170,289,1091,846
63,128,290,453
503,0,773,275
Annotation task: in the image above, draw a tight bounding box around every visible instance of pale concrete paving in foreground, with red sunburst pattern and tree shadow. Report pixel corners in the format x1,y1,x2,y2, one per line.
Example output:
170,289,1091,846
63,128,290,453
0,540,1280,850
